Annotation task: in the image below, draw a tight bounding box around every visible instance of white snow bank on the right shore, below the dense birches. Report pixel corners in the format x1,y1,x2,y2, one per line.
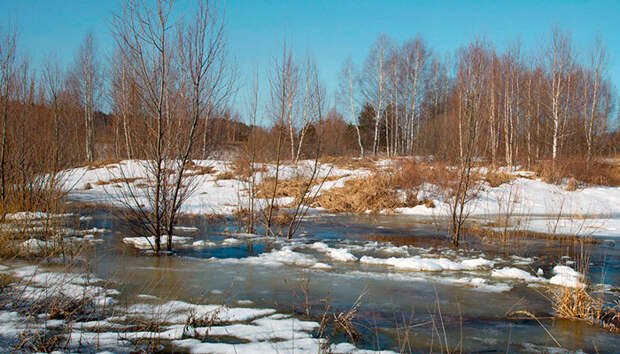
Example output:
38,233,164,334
397,175,620,237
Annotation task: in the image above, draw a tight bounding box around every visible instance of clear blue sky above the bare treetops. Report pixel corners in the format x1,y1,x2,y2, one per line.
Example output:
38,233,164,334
0,0,620,113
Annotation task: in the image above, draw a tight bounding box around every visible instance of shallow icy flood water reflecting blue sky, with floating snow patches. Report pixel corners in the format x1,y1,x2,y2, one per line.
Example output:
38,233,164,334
82,209,620,352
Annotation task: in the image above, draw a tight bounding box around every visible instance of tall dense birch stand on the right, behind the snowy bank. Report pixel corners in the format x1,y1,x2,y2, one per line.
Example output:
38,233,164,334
341,29,618,165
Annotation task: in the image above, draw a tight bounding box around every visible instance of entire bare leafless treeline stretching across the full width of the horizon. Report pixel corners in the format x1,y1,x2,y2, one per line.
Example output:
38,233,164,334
0,7,620,202
